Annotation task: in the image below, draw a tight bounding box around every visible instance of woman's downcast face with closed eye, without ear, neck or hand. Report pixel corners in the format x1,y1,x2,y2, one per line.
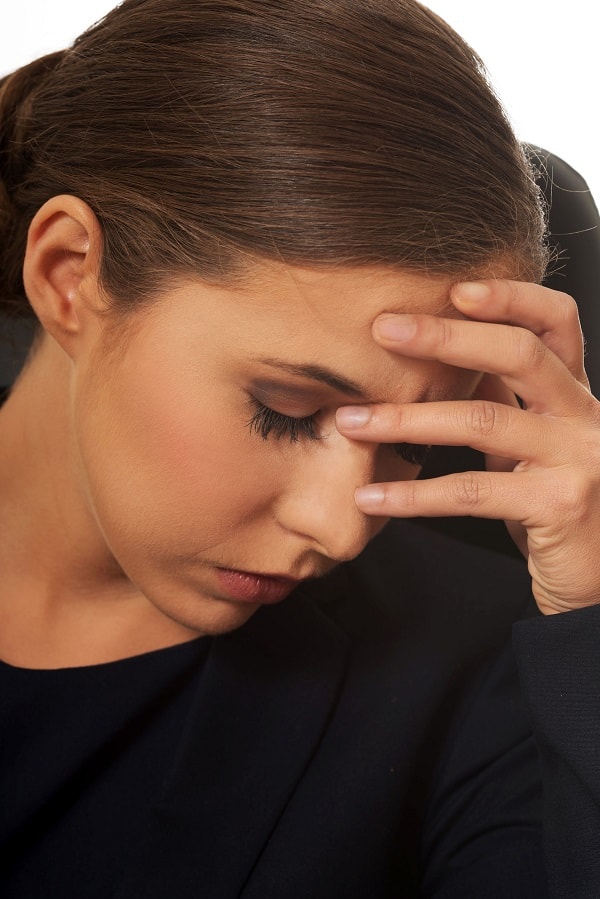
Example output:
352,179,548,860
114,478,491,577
73,264,475,633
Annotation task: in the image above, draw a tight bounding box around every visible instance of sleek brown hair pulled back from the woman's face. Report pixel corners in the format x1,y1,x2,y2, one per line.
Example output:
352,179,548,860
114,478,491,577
0,0,545,320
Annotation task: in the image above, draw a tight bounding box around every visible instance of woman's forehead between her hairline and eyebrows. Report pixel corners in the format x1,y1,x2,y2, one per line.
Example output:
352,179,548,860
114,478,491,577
137,263,474,401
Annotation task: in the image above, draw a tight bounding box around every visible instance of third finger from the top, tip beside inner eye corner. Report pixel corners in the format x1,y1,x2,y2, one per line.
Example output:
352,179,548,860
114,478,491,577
336,399,571,467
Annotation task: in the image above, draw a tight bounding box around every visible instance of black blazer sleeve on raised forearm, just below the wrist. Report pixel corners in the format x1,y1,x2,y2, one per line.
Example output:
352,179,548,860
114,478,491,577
513,606,600,899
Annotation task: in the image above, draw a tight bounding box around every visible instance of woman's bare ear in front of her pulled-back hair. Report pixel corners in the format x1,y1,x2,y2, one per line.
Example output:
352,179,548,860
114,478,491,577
23,196,104,357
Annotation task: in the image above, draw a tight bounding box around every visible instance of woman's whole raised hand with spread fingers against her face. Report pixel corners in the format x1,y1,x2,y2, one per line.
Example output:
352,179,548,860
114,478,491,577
337,281,600,614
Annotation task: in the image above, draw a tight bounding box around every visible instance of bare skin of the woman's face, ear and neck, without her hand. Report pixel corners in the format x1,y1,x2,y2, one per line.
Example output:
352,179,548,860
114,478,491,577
0,198,478,667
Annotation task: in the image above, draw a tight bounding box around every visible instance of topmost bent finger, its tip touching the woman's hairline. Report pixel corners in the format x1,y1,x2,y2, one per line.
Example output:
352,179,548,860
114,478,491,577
451,280,588,386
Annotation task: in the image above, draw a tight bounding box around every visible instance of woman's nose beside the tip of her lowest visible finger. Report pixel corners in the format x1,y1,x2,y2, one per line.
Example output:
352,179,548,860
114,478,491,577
275,431,381,562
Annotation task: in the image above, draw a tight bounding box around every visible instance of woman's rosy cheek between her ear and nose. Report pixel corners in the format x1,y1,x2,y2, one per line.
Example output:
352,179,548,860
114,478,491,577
72,358,278,555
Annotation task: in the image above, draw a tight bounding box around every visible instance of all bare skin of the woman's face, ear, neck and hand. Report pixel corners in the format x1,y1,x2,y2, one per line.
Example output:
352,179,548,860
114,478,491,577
0,197,600,667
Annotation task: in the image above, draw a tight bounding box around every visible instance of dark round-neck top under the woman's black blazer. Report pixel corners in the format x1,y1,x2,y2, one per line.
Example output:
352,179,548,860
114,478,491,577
0,639,210,899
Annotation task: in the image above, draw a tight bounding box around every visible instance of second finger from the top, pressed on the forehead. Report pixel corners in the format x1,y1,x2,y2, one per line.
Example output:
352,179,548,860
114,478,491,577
373,314,589,417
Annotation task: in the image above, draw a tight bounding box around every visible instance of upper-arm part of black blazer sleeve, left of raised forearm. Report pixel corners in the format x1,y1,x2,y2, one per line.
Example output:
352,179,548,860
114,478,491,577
420,647,548,899
